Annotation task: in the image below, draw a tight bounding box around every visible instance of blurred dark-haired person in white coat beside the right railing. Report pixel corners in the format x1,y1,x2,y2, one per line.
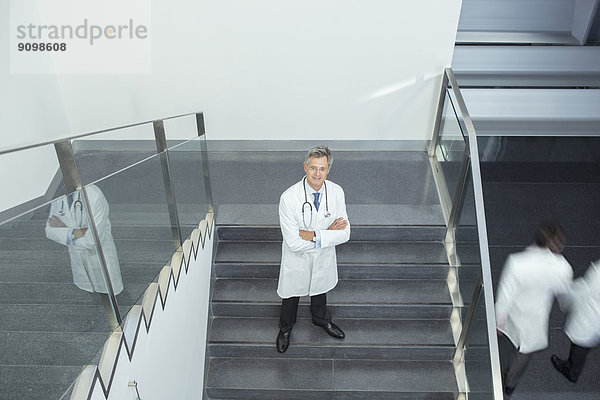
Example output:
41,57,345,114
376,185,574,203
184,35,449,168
496,224,573,398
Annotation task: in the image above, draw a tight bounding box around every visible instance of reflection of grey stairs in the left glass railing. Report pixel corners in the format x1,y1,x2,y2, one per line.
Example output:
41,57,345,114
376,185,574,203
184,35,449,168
0,204,173,400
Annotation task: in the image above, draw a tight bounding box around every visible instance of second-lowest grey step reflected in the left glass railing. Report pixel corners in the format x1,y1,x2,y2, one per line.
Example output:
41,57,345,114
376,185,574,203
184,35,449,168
0,331,110,366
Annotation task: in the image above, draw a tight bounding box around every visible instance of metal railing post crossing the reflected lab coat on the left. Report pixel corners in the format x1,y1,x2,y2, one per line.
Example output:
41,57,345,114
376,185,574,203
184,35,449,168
54,140,123,329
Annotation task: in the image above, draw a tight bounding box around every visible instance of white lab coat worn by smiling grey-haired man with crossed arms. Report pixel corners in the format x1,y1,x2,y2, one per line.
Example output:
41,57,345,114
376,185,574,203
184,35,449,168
277,181,350,299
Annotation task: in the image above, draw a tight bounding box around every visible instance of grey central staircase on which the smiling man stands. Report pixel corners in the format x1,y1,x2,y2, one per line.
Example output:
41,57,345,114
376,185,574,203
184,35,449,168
206,217,458,399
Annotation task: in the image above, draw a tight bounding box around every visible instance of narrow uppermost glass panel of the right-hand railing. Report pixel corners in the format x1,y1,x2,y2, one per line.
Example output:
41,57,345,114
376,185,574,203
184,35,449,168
436,90,466,205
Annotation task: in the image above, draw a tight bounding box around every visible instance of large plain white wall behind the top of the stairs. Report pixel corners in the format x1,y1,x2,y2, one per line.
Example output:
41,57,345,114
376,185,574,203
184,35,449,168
0,0,461,210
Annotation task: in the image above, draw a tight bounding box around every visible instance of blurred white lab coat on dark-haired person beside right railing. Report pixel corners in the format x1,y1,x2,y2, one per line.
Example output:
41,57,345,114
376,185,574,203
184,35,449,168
496,246,573,354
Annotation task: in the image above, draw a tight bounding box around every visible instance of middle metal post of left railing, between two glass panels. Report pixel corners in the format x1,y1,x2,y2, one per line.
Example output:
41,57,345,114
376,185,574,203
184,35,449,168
152,120,183,250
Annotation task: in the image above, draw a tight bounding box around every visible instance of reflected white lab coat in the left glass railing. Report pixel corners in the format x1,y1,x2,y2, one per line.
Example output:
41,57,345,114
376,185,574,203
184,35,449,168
46,185,123,294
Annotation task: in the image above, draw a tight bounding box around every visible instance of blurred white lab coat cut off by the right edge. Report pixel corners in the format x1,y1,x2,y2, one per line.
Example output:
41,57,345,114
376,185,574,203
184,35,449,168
565,260,600,347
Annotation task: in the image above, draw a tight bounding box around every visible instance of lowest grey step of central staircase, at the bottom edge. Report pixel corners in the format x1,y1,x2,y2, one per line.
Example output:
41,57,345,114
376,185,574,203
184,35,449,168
206,358,457,400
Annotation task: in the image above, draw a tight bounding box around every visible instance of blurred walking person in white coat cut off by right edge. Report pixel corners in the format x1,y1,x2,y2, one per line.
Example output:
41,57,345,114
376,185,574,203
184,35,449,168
550,260,600,383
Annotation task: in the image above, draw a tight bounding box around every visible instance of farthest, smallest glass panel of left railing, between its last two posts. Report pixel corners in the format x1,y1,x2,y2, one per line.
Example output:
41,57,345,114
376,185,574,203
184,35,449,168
168,136,212,240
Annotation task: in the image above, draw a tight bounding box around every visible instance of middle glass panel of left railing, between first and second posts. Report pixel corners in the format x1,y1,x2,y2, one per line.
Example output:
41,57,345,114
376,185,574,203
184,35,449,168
86,152,180,319
